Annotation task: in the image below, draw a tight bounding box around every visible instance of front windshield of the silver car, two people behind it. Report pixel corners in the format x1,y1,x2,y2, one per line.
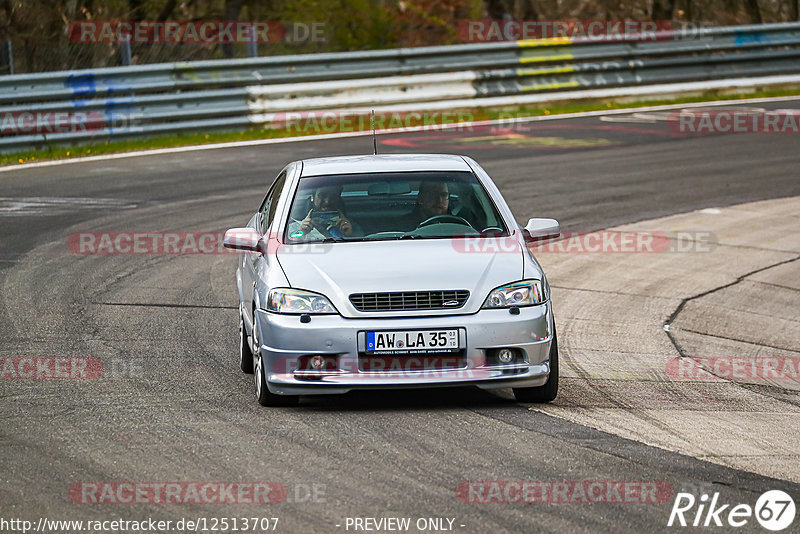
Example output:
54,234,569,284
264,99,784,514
285,171,507,243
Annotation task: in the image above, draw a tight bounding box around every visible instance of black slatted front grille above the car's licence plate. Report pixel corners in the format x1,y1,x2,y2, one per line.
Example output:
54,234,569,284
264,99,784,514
350,289,469,311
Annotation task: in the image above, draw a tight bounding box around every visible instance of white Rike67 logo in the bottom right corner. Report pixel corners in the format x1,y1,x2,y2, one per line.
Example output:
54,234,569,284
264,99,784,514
667,490,796,532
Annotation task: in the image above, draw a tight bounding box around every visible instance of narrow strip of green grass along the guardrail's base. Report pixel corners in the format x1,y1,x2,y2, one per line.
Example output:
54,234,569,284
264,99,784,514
0,87,800,165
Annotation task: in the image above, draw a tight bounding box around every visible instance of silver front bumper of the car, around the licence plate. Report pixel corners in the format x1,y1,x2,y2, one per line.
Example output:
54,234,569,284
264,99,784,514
256,302,553,395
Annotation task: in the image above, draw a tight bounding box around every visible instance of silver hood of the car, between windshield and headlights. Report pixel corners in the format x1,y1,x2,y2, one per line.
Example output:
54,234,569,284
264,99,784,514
277,238,523,317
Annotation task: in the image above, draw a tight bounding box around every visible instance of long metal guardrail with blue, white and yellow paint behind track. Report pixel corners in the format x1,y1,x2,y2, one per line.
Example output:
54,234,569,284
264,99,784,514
0,23,800,152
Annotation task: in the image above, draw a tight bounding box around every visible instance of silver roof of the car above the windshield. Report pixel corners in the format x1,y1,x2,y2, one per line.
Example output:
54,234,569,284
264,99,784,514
300,154,472,177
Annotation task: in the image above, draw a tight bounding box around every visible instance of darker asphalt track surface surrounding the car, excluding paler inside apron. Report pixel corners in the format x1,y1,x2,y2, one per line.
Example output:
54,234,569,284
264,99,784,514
0,102,800,532
